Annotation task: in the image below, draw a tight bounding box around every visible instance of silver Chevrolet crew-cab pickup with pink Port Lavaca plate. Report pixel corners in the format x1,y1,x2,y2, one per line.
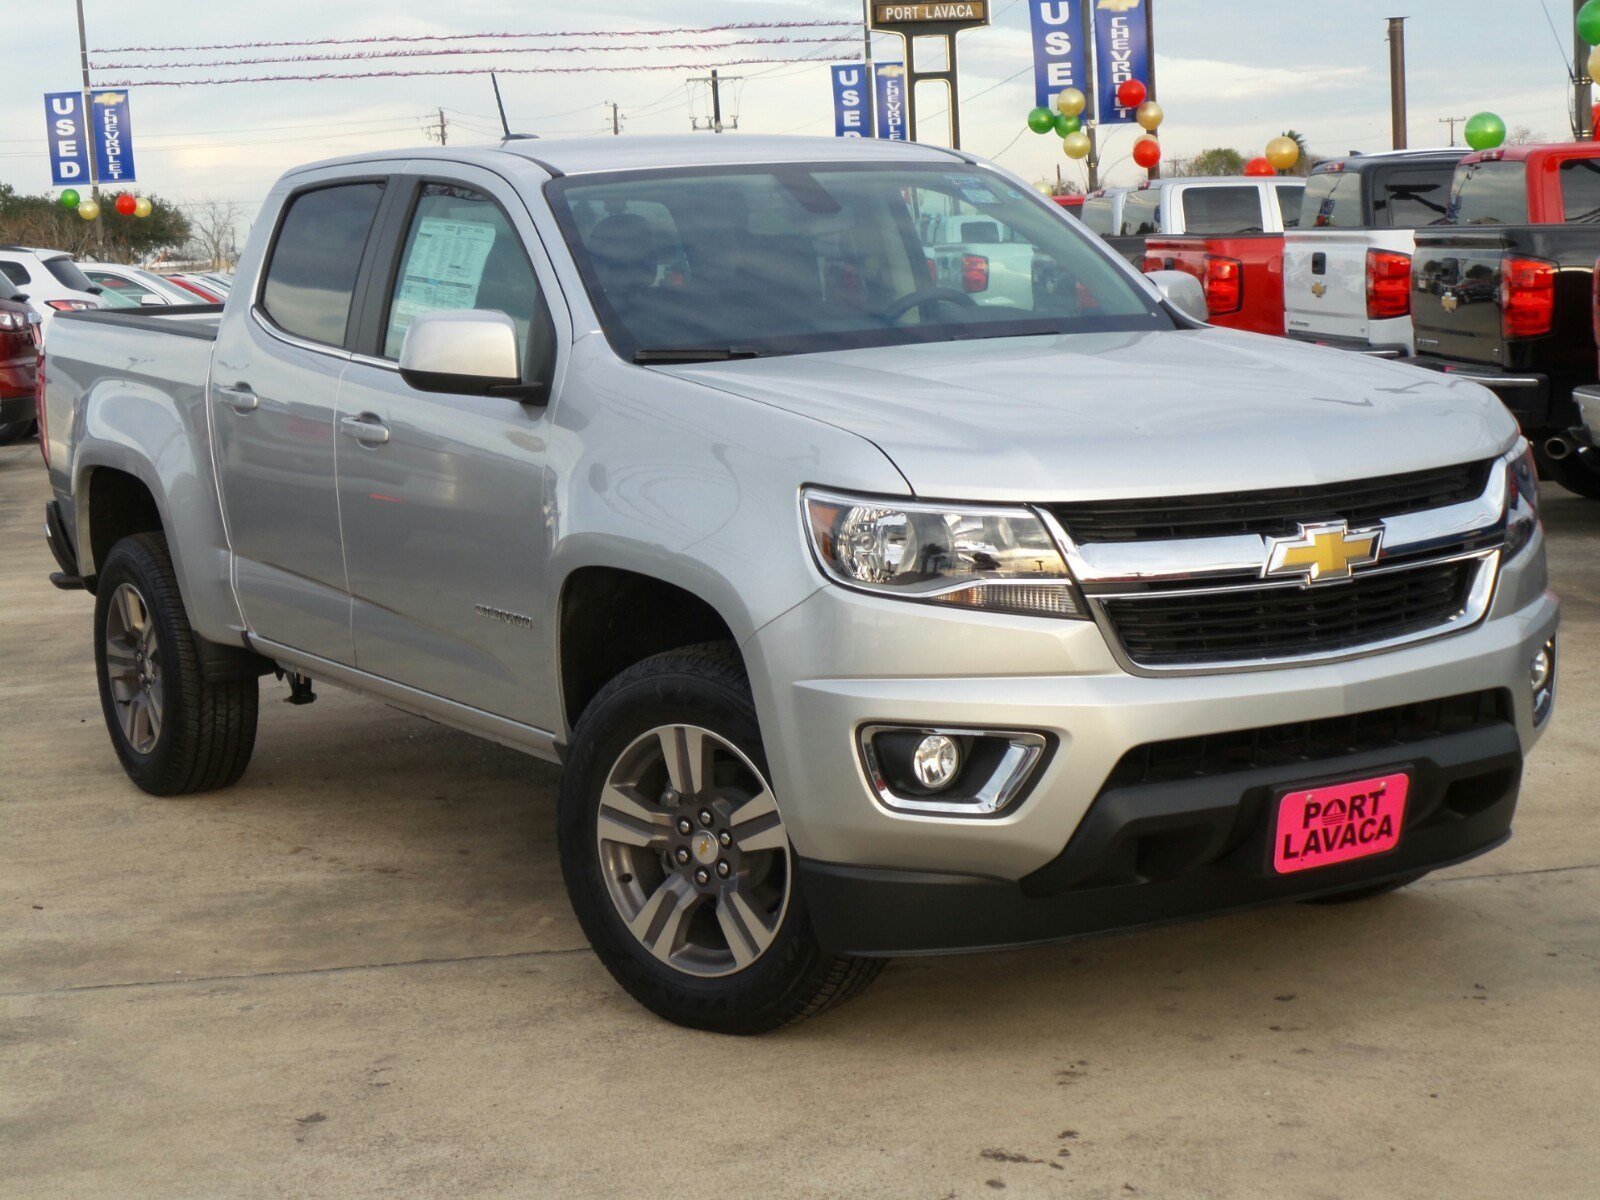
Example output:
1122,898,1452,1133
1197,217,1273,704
42,138,1557,1032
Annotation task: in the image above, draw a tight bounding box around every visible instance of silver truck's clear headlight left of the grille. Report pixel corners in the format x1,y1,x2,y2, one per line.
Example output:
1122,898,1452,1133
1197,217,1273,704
803,491,1086,618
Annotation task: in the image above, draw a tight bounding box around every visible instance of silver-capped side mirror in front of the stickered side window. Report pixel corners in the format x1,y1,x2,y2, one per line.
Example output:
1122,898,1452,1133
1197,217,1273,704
400,309,546,403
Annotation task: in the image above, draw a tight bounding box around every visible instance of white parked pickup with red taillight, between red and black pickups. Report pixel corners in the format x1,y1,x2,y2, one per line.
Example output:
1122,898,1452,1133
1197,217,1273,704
1283,149,1467,358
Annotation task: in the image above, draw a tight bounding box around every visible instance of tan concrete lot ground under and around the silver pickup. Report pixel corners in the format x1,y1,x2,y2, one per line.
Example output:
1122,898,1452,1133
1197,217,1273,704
0,445,1600,1200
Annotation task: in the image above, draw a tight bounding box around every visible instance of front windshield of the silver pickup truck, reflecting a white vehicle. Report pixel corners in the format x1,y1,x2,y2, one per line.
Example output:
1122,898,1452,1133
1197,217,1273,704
547,165,1173,362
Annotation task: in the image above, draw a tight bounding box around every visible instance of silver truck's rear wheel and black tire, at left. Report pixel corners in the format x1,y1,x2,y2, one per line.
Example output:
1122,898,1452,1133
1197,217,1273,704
94,533,259,795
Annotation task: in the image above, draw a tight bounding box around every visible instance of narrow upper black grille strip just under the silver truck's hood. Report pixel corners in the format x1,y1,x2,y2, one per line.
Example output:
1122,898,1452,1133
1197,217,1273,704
1050,461,1494,546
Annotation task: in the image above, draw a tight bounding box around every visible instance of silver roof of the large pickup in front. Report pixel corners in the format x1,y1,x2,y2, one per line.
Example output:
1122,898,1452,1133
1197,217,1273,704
290,134,976,176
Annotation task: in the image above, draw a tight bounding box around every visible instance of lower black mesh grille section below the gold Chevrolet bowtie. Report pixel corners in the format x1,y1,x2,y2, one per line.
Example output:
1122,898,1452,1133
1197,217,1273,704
1101,558,1488,669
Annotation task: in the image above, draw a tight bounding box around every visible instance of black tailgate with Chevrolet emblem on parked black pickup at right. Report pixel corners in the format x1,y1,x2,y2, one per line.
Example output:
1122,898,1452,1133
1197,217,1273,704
1411,229,1510,365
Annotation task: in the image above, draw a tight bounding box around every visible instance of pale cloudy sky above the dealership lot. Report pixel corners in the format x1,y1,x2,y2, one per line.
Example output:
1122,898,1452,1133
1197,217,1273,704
0,0,1573,240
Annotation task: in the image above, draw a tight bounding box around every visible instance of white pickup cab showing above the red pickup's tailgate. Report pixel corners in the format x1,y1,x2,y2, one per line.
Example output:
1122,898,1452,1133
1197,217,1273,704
1091,176,1306,266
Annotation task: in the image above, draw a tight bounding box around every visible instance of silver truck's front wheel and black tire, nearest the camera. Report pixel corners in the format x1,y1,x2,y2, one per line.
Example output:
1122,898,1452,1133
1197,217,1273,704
557,643,883,1034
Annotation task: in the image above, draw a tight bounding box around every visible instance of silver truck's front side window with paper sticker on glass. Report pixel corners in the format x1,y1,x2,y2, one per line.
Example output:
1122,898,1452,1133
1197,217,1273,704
384,184,550,374
